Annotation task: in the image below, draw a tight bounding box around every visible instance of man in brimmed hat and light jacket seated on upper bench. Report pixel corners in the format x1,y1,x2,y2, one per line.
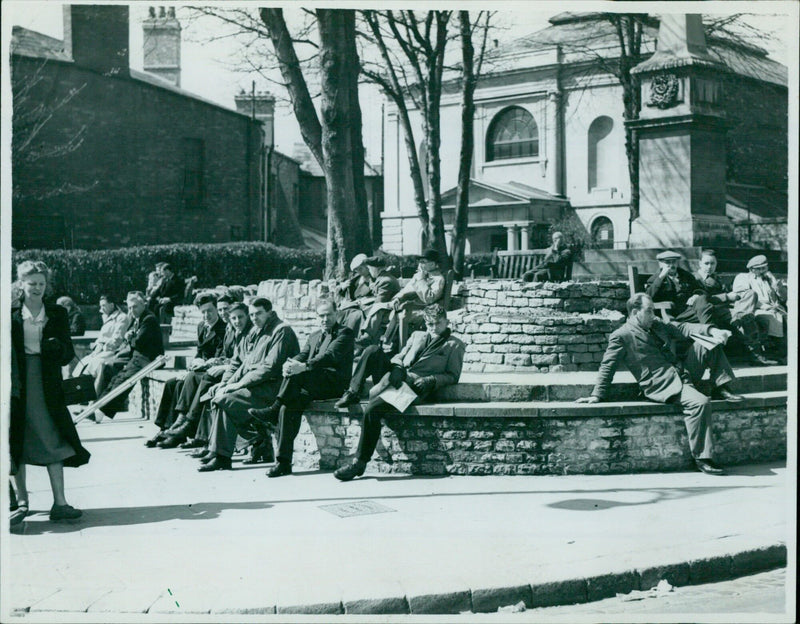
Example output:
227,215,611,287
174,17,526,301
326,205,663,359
381,249,445,353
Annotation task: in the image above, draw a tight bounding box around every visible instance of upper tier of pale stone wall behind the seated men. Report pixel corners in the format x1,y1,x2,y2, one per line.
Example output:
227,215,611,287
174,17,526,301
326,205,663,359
171,279,628,372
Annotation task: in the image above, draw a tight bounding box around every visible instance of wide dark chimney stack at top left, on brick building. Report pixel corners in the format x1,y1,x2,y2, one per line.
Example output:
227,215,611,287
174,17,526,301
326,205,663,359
64,4,130,75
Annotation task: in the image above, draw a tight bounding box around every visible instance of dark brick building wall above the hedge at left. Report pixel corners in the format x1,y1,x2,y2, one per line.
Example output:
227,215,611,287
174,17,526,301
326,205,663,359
12,56,263,249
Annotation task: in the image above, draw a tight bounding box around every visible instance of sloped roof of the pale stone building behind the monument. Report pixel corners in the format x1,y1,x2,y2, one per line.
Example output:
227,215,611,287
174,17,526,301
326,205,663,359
492,13,788,86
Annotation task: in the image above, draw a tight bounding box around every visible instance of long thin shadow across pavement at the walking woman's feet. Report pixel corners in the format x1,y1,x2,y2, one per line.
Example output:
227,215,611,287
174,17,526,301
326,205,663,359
13,501,272,535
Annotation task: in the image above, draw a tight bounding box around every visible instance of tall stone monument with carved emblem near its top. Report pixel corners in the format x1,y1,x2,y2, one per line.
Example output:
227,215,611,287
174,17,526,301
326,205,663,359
628,14,735,248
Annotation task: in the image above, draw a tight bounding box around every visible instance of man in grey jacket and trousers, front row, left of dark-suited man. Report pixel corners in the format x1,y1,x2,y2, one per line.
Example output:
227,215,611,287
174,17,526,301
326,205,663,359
198,297,300,472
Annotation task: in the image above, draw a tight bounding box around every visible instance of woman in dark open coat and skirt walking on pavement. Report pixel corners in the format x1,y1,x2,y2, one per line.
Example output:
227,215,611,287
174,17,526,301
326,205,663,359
9,260,89,521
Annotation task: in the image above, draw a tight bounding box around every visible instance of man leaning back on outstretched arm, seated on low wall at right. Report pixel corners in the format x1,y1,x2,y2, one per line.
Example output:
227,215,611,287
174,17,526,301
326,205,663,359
578,293,743,474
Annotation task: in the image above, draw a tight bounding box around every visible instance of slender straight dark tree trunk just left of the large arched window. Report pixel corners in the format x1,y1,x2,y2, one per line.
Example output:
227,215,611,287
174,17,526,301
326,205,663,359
450,11,477,278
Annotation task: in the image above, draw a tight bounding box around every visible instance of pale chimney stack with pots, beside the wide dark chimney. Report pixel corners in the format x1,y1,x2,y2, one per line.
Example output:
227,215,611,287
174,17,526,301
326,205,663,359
142,6,181,87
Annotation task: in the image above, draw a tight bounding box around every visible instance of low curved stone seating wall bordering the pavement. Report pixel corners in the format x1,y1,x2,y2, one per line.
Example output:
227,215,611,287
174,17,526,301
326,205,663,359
130,371,787,475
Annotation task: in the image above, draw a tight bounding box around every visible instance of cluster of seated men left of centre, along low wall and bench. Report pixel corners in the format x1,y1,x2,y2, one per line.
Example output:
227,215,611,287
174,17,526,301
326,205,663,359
139,252,465,481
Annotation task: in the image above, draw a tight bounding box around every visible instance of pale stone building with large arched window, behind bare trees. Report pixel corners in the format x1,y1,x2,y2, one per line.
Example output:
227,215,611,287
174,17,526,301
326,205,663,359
382,13,788,253
